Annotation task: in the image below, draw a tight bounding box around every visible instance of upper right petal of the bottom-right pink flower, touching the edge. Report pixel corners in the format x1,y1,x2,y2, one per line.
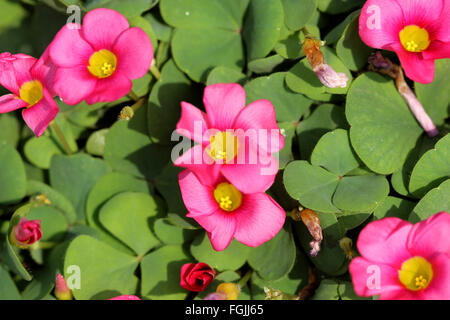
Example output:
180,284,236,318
407,212,450,258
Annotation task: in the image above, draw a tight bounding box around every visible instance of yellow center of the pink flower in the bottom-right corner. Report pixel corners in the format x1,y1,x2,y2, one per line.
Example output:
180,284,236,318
398,257,433,291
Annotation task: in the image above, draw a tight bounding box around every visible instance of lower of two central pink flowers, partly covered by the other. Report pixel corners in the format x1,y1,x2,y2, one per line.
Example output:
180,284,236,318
179,170,286,251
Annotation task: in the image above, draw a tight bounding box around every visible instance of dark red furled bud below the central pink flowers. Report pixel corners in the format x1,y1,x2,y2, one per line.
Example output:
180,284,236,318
180,262,216,292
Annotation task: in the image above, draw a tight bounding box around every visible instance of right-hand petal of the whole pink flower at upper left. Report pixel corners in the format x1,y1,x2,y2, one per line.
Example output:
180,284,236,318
113,28,153,80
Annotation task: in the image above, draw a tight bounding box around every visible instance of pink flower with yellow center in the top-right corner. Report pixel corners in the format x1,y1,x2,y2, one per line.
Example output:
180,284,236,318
359,0,450,83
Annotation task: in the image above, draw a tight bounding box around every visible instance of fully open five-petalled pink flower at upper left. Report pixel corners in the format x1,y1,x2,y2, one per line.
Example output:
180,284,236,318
50,8,153,105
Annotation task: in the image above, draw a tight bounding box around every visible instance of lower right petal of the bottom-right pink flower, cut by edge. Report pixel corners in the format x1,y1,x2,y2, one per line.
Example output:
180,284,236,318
423,253,450,300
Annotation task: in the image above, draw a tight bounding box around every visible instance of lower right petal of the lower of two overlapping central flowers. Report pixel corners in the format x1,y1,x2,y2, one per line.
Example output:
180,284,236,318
233,193,286,247
